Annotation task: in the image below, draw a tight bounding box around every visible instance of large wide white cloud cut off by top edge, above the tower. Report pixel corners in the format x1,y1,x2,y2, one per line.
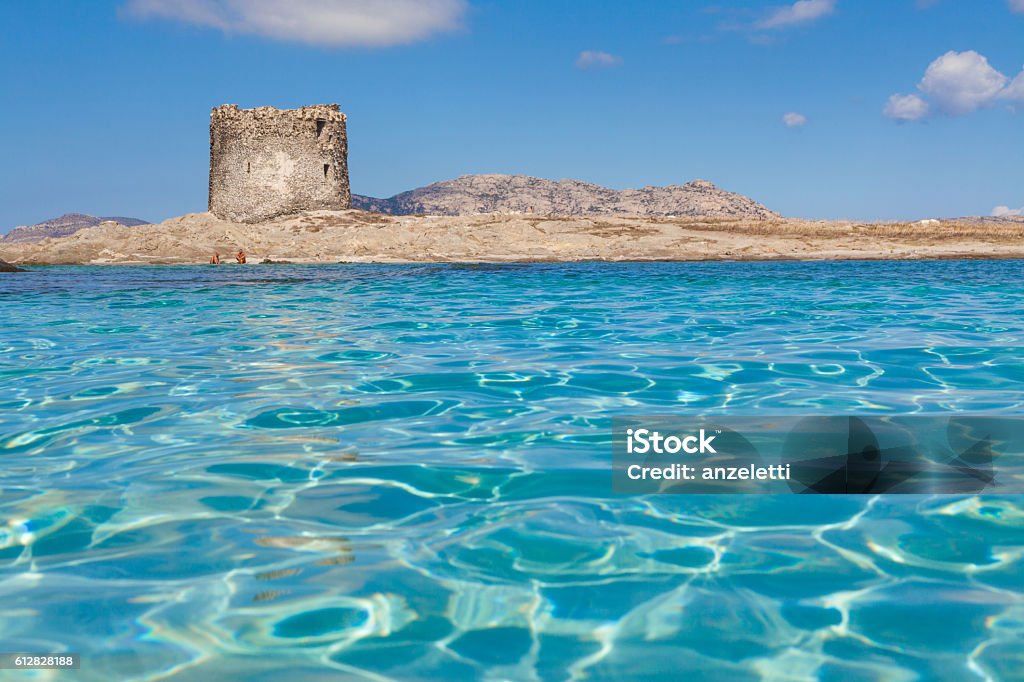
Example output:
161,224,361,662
123,0,467,47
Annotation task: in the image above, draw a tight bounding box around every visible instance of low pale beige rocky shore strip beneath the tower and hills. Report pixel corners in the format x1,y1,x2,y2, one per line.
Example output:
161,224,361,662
0,210,1024,265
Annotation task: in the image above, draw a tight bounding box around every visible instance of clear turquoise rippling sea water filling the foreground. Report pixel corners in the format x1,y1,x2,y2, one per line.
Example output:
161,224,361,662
0,261,1024,681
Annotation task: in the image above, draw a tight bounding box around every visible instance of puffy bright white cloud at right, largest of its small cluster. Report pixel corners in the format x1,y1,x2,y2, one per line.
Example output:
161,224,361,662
918,50,1009,116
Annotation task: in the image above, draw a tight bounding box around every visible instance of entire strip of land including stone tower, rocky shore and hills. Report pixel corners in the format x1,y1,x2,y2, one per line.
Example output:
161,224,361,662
0,104,1024,264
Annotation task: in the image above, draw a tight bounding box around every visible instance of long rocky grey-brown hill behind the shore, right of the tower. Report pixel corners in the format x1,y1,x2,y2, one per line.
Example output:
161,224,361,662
352,174,781,220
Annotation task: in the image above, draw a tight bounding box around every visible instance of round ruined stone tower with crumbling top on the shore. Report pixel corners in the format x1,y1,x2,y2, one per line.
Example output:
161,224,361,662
210,104,352,222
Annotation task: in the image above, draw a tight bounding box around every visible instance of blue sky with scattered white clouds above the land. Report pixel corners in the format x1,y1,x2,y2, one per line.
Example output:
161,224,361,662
0,0,1024,231
